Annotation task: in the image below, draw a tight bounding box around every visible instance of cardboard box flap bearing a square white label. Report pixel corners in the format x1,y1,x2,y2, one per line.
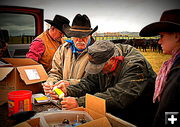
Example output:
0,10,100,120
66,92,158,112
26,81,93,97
17,64,48,85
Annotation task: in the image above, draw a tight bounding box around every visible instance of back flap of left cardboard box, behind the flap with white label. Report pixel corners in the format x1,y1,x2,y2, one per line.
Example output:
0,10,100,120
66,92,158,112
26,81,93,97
2,58,39,67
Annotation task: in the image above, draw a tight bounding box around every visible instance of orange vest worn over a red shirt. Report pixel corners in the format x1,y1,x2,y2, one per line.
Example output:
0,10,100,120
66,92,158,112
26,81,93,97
37,30,60,72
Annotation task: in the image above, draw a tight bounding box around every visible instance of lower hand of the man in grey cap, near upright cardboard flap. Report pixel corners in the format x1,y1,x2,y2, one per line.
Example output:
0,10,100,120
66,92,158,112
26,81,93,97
61,97,79,110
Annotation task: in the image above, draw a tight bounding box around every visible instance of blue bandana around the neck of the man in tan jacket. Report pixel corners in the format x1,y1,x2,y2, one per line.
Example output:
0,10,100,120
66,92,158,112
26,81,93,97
65,39,91,53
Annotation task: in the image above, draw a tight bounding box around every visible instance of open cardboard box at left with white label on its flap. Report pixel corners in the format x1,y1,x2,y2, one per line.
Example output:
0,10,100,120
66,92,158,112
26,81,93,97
0,58,48,105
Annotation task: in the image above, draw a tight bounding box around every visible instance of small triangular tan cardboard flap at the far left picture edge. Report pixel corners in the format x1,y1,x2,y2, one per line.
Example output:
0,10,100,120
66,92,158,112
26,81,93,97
0,67,14,81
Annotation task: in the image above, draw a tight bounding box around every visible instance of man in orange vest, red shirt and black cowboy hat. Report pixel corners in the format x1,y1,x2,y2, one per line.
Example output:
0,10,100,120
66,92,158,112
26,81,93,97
26,15,69,72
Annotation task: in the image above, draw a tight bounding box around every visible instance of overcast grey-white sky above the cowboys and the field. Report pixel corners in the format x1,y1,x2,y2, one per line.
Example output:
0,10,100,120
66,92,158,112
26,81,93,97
0,0,180,32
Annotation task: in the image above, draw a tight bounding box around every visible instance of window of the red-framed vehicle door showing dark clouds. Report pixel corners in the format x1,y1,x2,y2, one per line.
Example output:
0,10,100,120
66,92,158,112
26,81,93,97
0,13,36,44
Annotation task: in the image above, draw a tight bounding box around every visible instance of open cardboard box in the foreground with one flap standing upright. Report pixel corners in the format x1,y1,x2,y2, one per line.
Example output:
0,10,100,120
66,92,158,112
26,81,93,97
16,94,135,127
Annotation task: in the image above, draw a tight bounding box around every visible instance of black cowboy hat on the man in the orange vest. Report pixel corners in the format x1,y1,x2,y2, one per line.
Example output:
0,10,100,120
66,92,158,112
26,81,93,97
44,15,70,35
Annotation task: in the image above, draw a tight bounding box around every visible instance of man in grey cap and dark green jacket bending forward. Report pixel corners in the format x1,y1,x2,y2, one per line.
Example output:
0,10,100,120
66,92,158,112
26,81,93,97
59,40,156,127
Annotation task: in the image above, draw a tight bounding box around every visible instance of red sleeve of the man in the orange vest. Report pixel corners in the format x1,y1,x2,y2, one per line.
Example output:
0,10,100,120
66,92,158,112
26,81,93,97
26,39,45,61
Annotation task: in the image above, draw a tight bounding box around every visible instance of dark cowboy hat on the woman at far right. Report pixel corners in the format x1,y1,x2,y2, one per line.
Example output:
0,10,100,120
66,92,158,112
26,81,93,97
139,9,180,37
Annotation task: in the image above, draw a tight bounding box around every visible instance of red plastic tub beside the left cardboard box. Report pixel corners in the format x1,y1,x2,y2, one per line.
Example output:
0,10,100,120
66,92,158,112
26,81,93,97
8,90,32,116
